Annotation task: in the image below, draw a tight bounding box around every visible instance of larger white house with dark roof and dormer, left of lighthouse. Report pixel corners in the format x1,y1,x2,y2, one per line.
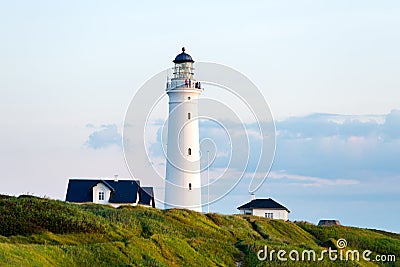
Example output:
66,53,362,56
65,179,155,208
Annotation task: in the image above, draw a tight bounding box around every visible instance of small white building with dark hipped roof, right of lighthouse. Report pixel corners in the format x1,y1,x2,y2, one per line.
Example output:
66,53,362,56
237,197,290,221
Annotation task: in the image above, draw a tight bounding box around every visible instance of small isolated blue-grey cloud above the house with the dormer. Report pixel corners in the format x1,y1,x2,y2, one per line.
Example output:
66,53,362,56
85,124,122,149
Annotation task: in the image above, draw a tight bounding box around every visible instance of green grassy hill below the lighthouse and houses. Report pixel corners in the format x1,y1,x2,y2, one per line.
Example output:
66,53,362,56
0,196,400,267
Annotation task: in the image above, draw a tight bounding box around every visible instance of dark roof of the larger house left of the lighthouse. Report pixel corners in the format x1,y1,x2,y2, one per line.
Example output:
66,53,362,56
65,179,140,203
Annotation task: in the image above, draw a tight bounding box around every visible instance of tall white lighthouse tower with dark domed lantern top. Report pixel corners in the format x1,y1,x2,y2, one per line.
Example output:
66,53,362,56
165,48,202,212
